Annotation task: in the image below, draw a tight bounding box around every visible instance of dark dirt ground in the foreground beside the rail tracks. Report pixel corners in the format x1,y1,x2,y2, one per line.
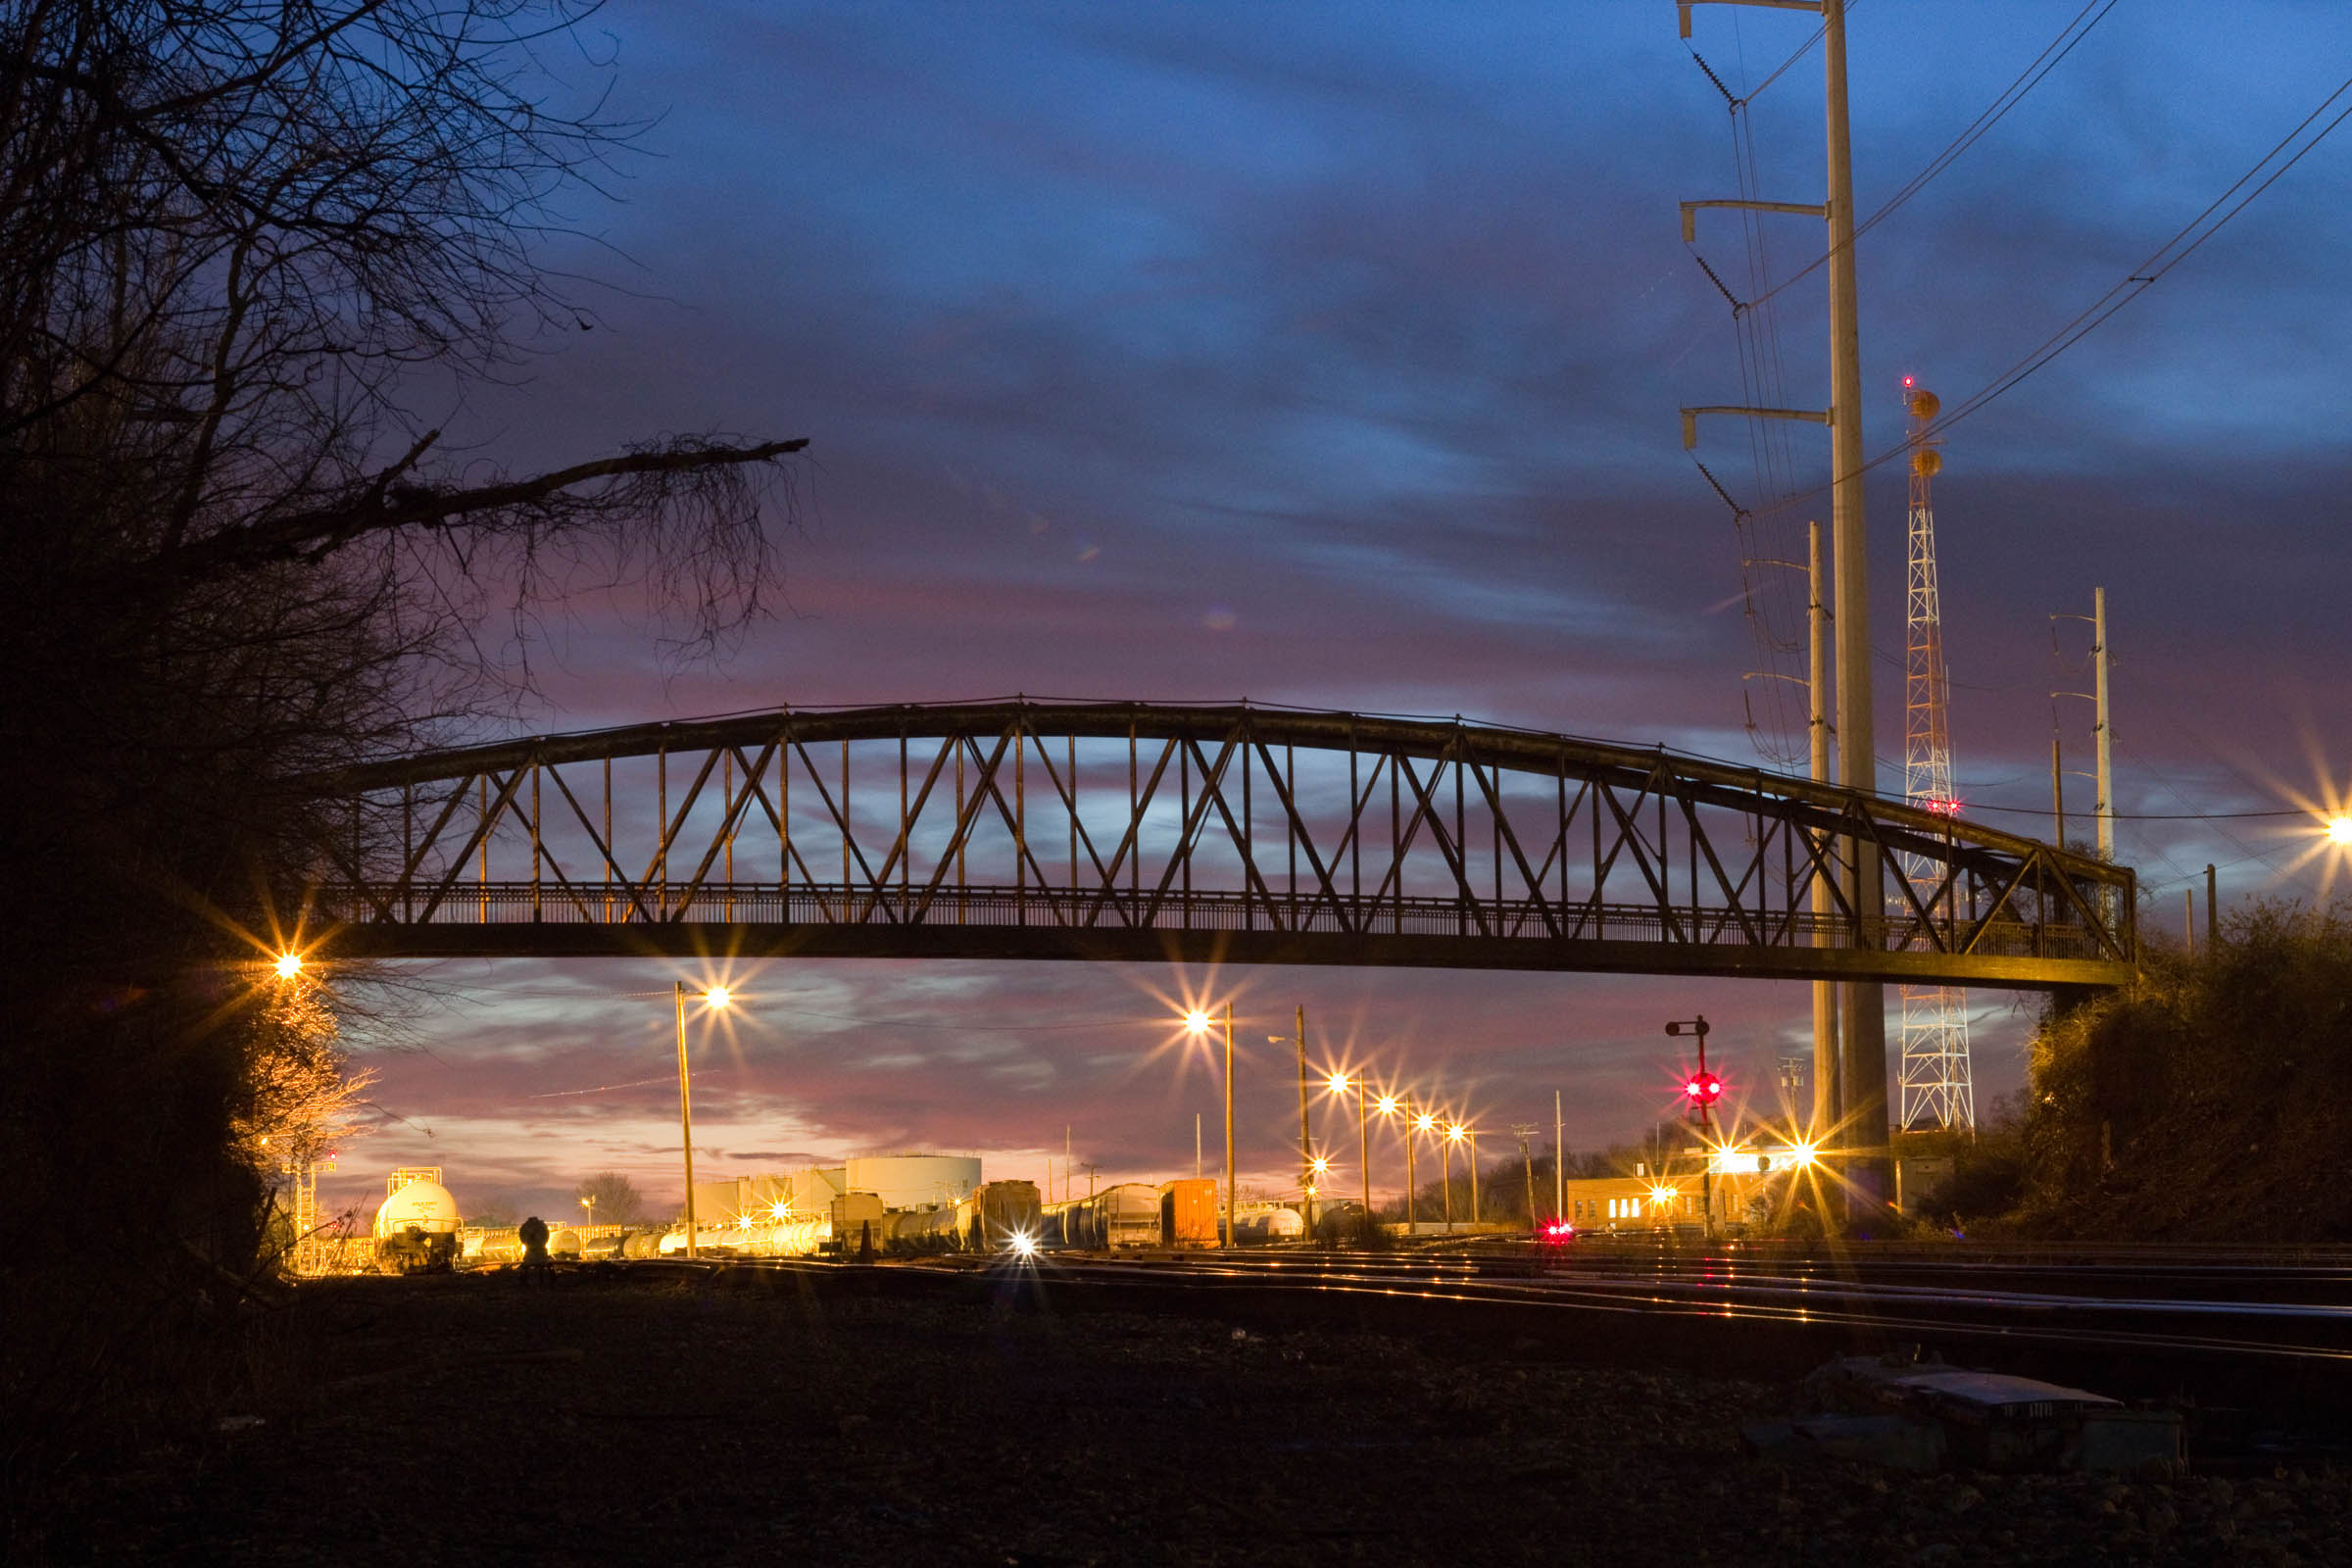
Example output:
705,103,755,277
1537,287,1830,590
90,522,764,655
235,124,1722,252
47,1269,2352,1568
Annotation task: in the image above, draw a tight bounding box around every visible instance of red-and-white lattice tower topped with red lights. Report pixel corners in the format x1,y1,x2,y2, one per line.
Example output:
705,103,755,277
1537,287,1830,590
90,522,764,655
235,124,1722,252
1895,376,1976,1131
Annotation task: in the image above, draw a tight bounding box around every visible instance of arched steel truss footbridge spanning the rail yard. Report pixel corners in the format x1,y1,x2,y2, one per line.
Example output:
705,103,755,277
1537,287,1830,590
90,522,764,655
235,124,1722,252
308,701,2138,987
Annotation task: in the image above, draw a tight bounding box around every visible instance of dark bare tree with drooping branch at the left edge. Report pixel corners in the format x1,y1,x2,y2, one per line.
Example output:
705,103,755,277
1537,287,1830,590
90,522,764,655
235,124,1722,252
0,0,802,1513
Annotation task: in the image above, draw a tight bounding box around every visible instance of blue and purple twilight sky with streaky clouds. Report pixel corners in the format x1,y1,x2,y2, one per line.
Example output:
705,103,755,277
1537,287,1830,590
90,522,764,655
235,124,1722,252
327,0,2352,1213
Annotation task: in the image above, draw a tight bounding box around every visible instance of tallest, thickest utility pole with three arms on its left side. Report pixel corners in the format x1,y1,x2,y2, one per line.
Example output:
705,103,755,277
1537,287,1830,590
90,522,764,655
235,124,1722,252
1675,0,1886,1215
